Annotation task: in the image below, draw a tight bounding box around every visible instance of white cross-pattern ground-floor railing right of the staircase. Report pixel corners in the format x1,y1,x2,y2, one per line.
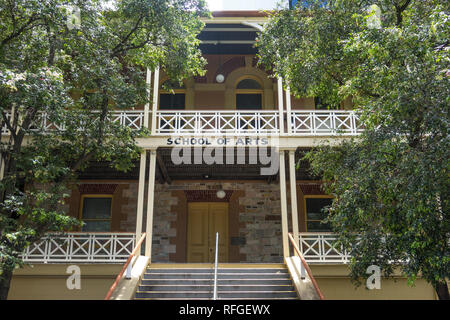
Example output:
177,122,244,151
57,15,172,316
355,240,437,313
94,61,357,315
299,232,350,264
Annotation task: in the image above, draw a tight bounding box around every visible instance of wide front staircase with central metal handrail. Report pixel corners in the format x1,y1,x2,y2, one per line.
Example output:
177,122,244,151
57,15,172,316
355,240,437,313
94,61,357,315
135,264,298,300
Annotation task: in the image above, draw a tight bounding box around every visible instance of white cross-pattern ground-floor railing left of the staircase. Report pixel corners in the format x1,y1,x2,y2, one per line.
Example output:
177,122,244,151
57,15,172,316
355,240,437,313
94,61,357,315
23,232,136,263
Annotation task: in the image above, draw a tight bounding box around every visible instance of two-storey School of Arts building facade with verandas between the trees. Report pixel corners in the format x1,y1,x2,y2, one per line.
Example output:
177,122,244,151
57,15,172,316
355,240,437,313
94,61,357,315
5,11,436,299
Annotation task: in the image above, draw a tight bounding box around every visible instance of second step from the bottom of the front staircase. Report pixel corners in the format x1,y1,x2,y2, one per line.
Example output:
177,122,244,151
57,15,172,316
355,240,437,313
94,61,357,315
138,284,295,292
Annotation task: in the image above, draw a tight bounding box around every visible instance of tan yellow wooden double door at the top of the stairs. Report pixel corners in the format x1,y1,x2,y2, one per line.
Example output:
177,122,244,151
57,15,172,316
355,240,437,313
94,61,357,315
187,202,229,263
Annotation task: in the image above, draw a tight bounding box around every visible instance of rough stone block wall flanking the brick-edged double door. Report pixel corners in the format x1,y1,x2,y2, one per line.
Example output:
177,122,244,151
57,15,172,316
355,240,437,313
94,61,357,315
149,182,282,263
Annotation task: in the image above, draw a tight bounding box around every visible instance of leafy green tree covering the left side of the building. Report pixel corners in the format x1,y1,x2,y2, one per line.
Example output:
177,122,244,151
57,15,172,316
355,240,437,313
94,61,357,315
0,0,207,299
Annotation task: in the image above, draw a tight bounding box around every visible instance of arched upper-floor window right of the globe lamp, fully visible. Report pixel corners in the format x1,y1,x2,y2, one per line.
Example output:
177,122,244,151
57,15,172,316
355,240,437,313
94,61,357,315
236,78,264,110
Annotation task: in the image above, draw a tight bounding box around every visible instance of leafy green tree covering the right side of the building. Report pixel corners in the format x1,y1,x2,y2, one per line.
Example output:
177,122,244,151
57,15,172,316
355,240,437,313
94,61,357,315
258,0,450,299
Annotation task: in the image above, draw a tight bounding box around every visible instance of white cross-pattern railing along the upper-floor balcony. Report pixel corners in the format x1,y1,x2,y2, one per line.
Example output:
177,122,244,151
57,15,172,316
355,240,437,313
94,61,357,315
1,110,363,137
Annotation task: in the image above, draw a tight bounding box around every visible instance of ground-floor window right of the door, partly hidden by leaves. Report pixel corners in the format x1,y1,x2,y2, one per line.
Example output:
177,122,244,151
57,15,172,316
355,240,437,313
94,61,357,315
305,196,333,232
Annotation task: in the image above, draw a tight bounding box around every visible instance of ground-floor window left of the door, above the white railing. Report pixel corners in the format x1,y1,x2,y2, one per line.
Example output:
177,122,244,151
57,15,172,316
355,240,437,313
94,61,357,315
81,195,112,232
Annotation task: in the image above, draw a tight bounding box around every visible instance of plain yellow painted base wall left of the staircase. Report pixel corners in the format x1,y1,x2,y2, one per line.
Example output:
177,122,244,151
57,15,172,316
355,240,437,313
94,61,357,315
8,264,122,300
